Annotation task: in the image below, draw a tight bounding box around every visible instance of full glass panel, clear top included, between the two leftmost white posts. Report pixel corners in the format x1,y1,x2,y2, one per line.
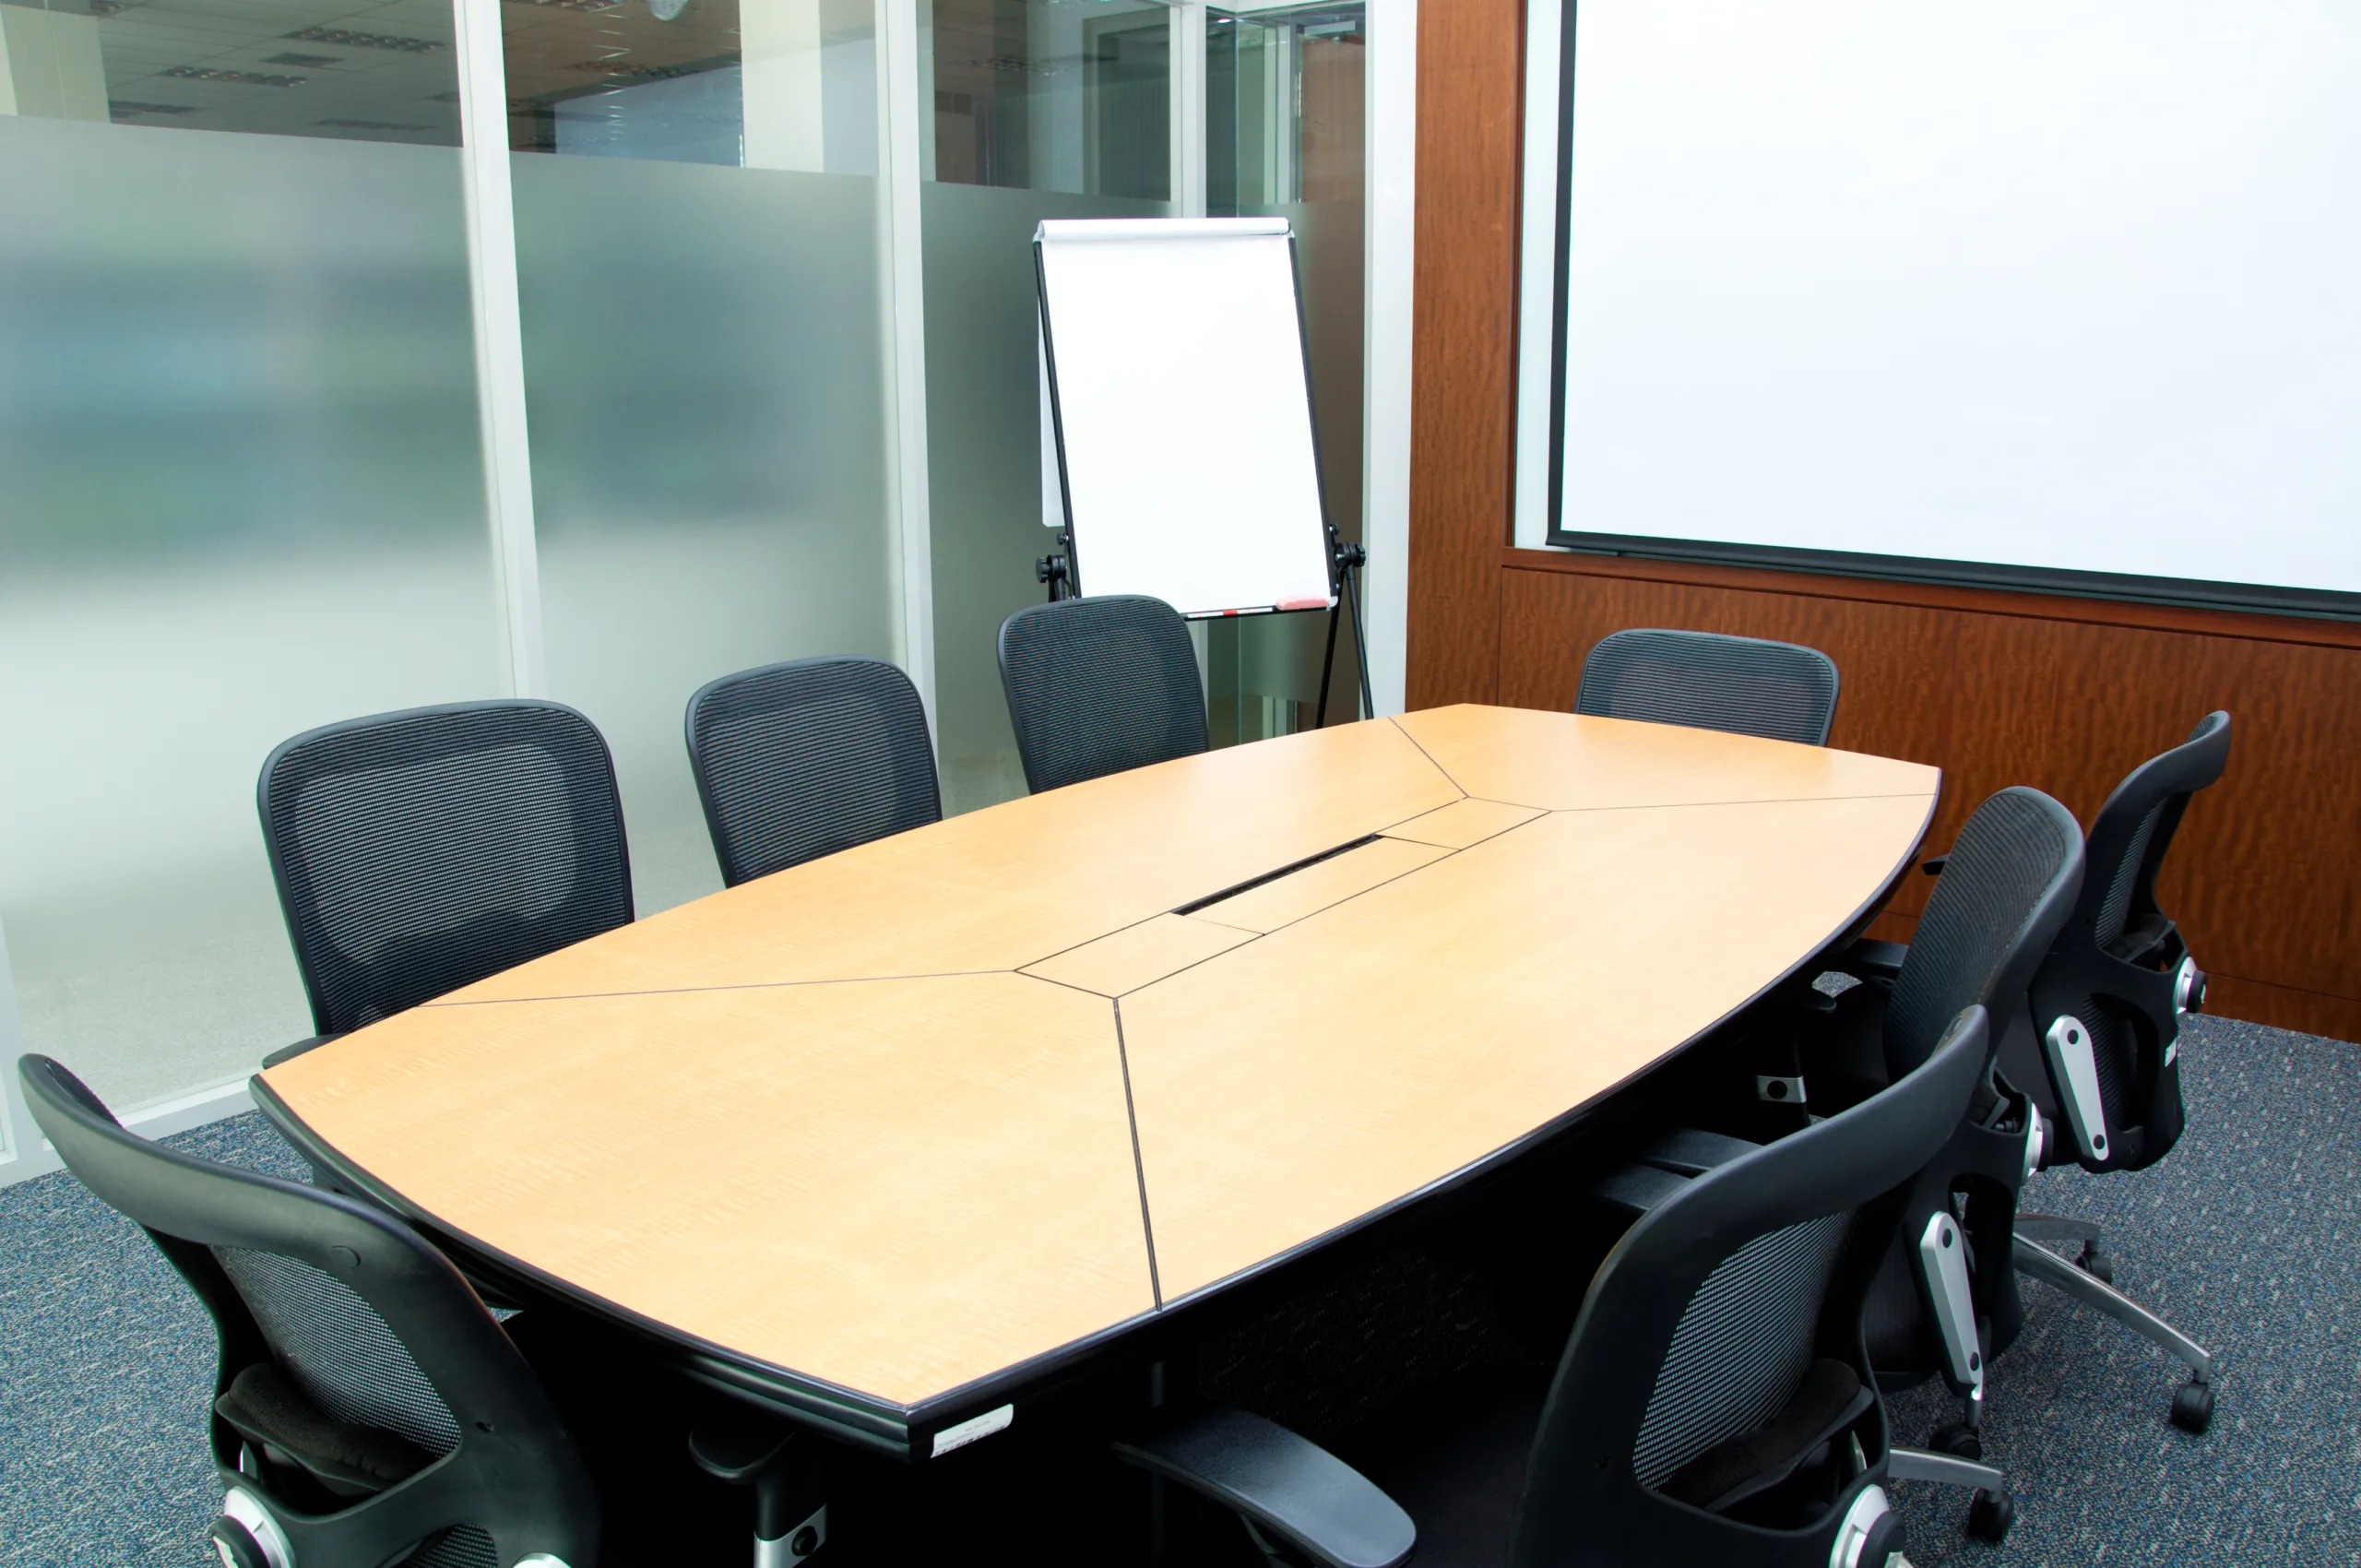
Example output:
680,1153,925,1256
503,0,899,914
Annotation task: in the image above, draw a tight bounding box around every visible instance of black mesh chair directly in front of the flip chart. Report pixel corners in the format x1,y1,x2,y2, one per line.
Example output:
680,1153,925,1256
1001,595,1206,793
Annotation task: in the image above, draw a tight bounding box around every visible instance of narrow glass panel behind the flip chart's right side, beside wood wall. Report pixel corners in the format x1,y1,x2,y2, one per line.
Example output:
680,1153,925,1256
1206,3,1367,746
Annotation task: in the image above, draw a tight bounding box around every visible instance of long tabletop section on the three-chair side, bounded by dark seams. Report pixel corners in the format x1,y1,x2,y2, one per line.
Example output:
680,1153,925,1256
432,720,1459,1002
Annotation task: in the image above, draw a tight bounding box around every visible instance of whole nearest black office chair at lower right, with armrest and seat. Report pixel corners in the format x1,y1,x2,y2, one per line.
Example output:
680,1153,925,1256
1117,1008,1999,1568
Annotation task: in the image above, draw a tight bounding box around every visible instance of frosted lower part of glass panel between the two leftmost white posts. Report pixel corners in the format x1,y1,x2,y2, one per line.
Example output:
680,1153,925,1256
515,153,892,914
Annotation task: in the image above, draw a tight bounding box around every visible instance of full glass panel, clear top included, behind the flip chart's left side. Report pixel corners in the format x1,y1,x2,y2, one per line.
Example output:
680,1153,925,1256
919,0,1173,813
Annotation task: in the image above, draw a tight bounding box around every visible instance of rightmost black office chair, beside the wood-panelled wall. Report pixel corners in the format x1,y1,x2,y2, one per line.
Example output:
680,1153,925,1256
2004,713,2229,1431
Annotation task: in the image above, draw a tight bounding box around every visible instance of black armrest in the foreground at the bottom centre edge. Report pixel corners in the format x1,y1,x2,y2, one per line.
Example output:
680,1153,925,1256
1114,1409,1419,1568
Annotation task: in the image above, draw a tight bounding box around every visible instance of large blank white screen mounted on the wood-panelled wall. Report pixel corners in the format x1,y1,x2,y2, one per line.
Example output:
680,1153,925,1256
1521,0,2361,614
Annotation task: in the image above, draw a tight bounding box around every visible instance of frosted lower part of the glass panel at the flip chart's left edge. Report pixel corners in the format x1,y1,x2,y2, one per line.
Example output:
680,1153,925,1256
919,184,1171,813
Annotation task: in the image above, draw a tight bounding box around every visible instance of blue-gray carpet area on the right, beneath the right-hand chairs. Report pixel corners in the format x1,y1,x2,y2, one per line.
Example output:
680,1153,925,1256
1893,1017,2361,1568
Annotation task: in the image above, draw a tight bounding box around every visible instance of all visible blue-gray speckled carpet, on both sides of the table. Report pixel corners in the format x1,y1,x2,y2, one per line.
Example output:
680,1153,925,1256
0,1020,2361,1568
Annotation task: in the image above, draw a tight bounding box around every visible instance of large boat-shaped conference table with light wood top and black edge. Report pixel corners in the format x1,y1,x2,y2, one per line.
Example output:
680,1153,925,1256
255,707,1939,1459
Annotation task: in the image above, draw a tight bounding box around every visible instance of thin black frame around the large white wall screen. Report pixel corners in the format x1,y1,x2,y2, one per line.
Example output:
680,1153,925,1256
1542,0,2361,621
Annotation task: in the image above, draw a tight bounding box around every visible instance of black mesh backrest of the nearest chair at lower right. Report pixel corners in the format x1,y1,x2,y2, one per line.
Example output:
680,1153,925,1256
1511,1008,1990,1568
